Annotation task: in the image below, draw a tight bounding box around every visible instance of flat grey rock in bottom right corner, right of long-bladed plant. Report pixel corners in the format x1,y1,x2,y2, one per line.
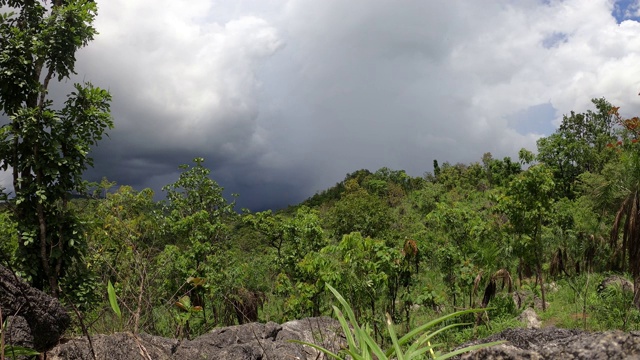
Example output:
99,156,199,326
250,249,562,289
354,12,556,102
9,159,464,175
460,327,640,360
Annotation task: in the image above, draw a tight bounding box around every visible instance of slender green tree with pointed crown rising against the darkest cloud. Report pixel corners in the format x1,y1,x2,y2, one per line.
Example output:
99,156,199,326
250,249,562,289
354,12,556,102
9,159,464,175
156,158,238,333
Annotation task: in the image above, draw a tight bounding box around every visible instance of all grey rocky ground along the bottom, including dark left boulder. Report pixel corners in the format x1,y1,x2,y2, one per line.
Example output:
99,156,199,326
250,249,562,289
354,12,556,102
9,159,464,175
0,266,640,360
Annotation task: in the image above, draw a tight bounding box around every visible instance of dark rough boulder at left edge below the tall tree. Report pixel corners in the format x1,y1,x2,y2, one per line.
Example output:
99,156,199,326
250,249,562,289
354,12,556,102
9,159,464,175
0,266,71,351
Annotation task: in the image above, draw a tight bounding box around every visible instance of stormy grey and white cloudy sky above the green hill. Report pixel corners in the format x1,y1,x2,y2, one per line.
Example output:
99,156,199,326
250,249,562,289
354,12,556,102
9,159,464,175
27,0,640,210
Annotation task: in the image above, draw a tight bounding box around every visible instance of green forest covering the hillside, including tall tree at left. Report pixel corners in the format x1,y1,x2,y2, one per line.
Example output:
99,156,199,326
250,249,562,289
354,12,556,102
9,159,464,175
0,0,640,354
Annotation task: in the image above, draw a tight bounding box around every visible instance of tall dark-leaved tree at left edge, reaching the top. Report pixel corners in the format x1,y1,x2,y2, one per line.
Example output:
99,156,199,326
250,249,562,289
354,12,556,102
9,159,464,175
0,0,113,296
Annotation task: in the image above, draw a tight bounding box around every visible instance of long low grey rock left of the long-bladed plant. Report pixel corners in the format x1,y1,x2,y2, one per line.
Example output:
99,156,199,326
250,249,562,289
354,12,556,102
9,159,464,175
47,317,345,360
